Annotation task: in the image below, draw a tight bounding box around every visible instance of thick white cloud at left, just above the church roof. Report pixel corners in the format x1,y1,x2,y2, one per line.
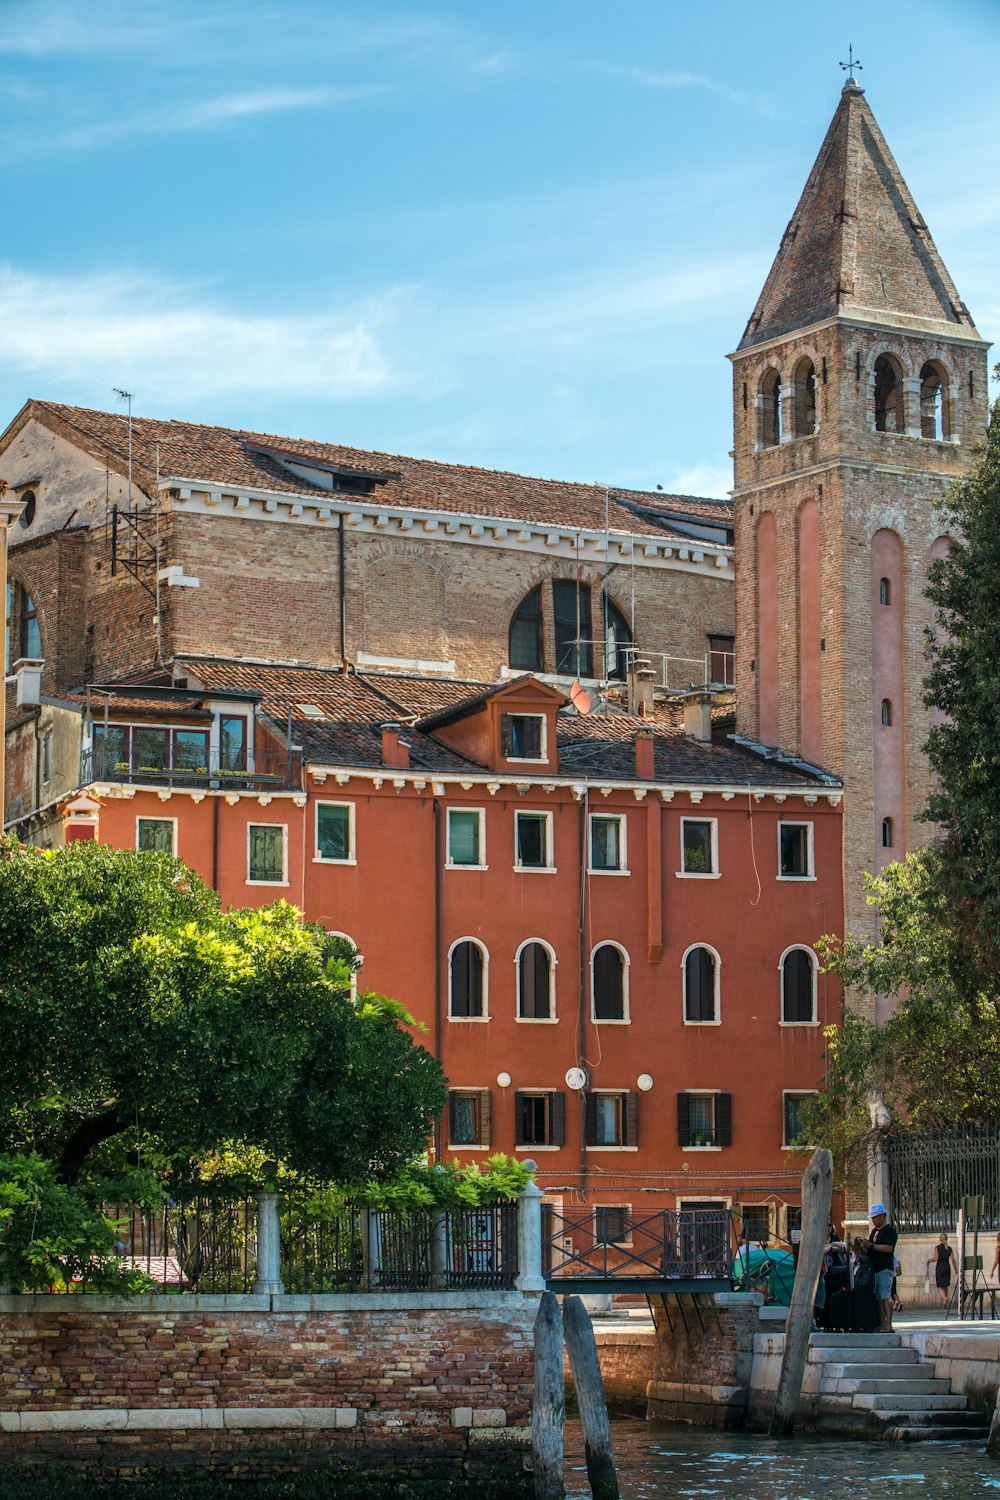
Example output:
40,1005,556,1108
0,264,393,410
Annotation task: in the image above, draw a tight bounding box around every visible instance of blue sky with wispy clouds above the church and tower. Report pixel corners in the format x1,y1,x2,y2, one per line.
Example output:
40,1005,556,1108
0,0,1000,494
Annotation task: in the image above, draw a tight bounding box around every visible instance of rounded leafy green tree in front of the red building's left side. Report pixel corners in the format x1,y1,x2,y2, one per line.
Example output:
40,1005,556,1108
0,840,445,1184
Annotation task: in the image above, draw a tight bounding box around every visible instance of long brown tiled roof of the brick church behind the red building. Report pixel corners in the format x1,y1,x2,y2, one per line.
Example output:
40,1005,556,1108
9,401,732,540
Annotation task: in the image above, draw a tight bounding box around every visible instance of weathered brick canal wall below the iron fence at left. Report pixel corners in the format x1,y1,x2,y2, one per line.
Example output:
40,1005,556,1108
0,1293,535,1494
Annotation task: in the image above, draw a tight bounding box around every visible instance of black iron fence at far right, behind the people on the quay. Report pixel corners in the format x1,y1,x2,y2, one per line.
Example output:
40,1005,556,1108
888,1127,1000,1233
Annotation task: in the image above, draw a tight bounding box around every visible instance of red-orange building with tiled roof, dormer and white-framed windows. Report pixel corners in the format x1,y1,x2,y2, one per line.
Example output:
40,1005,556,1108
64,660,843,1233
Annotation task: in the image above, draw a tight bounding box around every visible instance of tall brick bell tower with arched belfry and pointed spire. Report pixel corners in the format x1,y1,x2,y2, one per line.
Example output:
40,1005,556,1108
730,77,990,1008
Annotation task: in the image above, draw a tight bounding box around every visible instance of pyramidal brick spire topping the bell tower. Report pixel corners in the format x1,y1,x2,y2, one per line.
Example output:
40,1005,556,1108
739,78,976,350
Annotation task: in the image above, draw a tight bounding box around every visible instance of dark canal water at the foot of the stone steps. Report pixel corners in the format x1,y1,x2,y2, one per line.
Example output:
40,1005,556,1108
565,1422,1000,1500
